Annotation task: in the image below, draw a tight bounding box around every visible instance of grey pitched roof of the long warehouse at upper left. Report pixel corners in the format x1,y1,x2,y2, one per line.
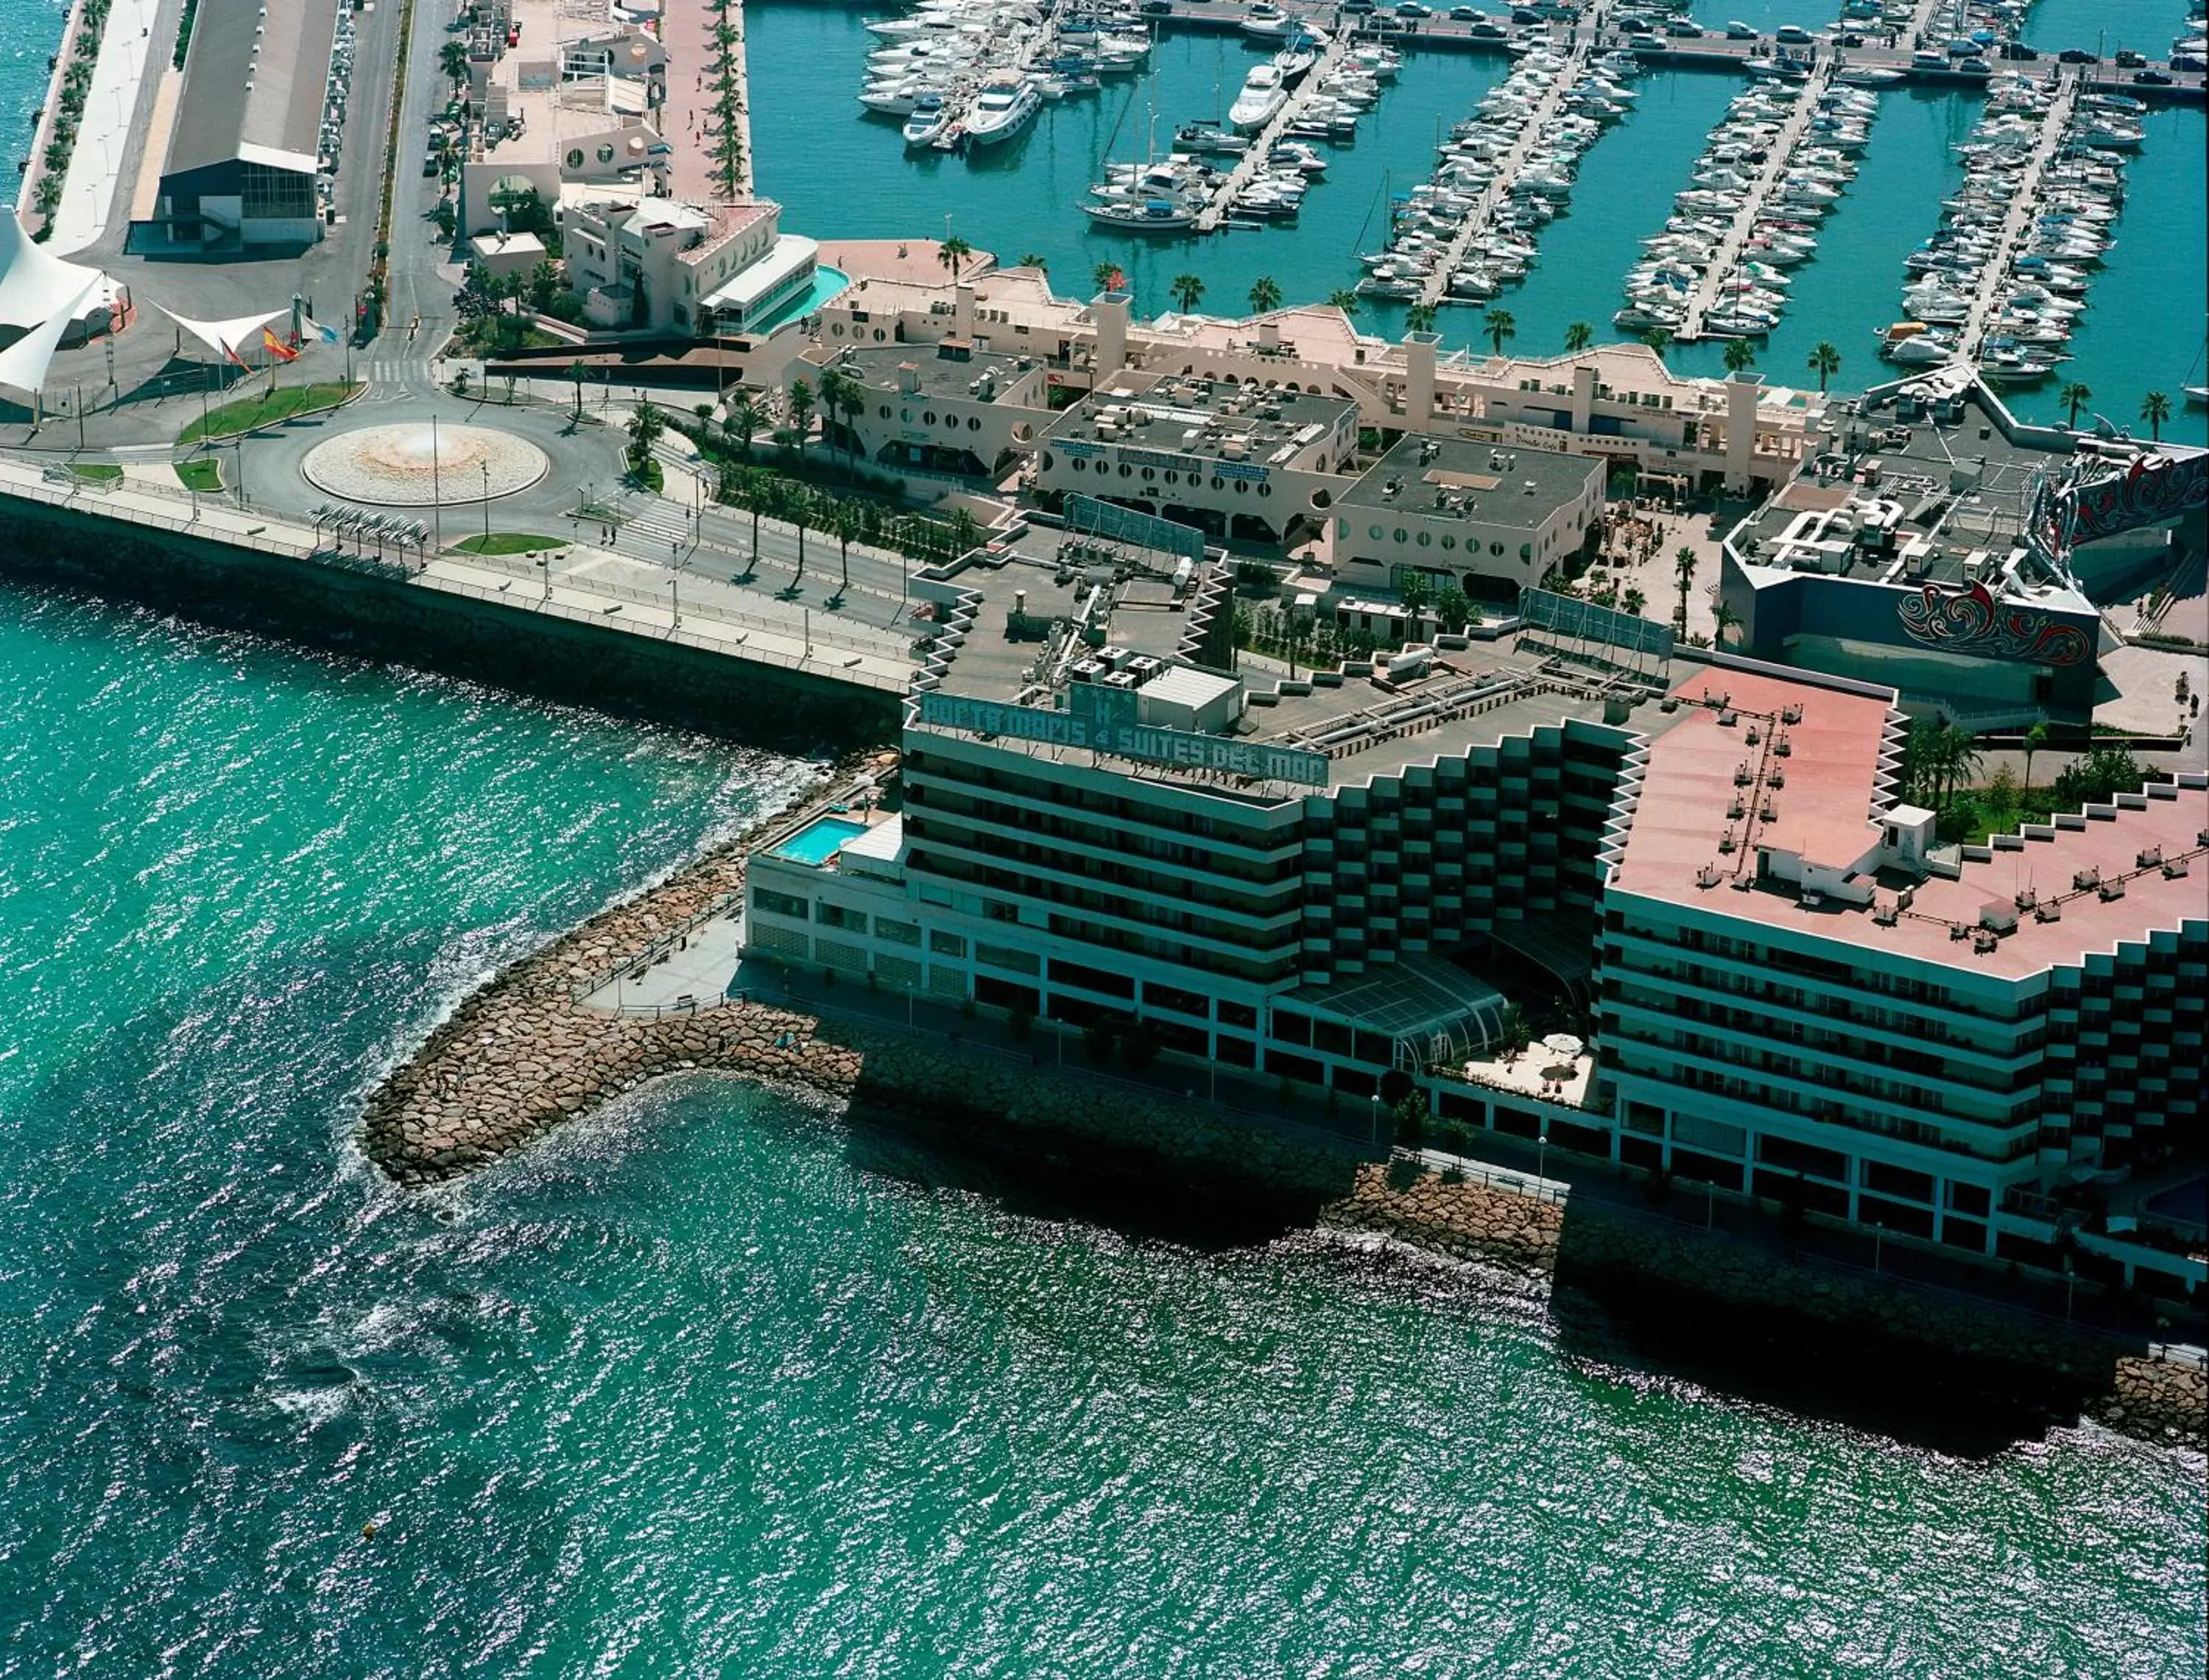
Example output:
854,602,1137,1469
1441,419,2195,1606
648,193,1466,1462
161,0,338,174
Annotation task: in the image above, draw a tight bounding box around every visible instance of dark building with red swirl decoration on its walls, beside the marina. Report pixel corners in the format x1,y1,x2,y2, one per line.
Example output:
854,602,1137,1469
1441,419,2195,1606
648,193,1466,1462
1721,367,2209,731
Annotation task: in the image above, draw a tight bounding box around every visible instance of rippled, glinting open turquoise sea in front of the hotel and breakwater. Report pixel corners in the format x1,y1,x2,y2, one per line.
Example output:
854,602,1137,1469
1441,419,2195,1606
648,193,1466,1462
0,590,2205,1680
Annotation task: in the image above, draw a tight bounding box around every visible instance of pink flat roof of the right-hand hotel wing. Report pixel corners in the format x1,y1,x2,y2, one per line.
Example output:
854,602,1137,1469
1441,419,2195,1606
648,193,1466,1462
1613,669,2209,980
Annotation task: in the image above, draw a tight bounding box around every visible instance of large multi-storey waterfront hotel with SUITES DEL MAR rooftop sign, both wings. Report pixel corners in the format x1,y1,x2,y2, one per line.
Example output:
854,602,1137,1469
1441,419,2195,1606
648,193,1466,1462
744,549,2209,1289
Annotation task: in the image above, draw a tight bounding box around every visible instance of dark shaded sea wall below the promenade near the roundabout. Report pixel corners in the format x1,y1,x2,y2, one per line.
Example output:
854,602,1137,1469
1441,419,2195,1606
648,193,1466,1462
0,497,897,753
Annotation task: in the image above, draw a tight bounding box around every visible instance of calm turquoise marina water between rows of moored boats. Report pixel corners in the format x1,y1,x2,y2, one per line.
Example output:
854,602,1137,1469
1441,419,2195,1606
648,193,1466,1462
747,0,2209,426
